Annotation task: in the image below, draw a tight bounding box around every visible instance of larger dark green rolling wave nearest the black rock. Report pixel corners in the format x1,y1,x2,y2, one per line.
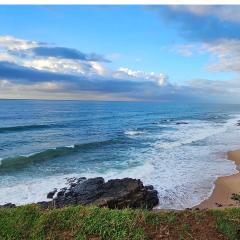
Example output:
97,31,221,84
0,139,120,170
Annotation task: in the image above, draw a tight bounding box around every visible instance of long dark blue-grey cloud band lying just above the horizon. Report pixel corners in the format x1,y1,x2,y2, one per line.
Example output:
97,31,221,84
0,62,197,101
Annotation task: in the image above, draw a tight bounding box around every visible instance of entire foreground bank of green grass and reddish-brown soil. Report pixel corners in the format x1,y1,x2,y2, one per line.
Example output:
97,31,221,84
0,205,240,240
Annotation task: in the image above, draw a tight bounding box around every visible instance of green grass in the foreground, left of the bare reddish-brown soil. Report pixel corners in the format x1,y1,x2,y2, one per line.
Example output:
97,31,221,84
0,205,146,240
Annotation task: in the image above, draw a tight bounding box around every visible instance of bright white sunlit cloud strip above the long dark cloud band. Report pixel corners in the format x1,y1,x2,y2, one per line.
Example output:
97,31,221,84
0,36,168,86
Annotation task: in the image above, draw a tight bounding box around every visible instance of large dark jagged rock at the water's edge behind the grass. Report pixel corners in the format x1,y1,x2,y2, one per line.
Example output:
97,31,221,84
53,177,159,209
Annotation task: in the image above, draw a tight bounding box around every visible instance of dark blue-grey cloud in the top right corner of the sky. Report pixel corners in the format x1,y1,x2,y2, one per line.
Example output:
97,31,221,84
151,5,240,41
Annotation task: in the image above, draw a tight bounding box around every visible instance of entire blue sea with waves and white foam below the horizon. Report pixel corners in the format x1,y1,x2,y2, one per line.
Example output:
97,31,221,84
0,100,240,209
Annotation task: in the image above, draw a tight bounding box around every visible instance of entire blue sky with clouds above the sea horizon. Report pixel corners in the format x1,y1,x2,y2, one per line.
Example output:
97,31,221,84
0,5,240,103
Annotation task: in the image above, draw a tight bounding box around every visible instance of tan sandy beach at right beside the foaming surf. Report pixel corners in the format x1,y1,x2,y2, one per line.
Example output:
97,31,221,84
196,150,240,209
